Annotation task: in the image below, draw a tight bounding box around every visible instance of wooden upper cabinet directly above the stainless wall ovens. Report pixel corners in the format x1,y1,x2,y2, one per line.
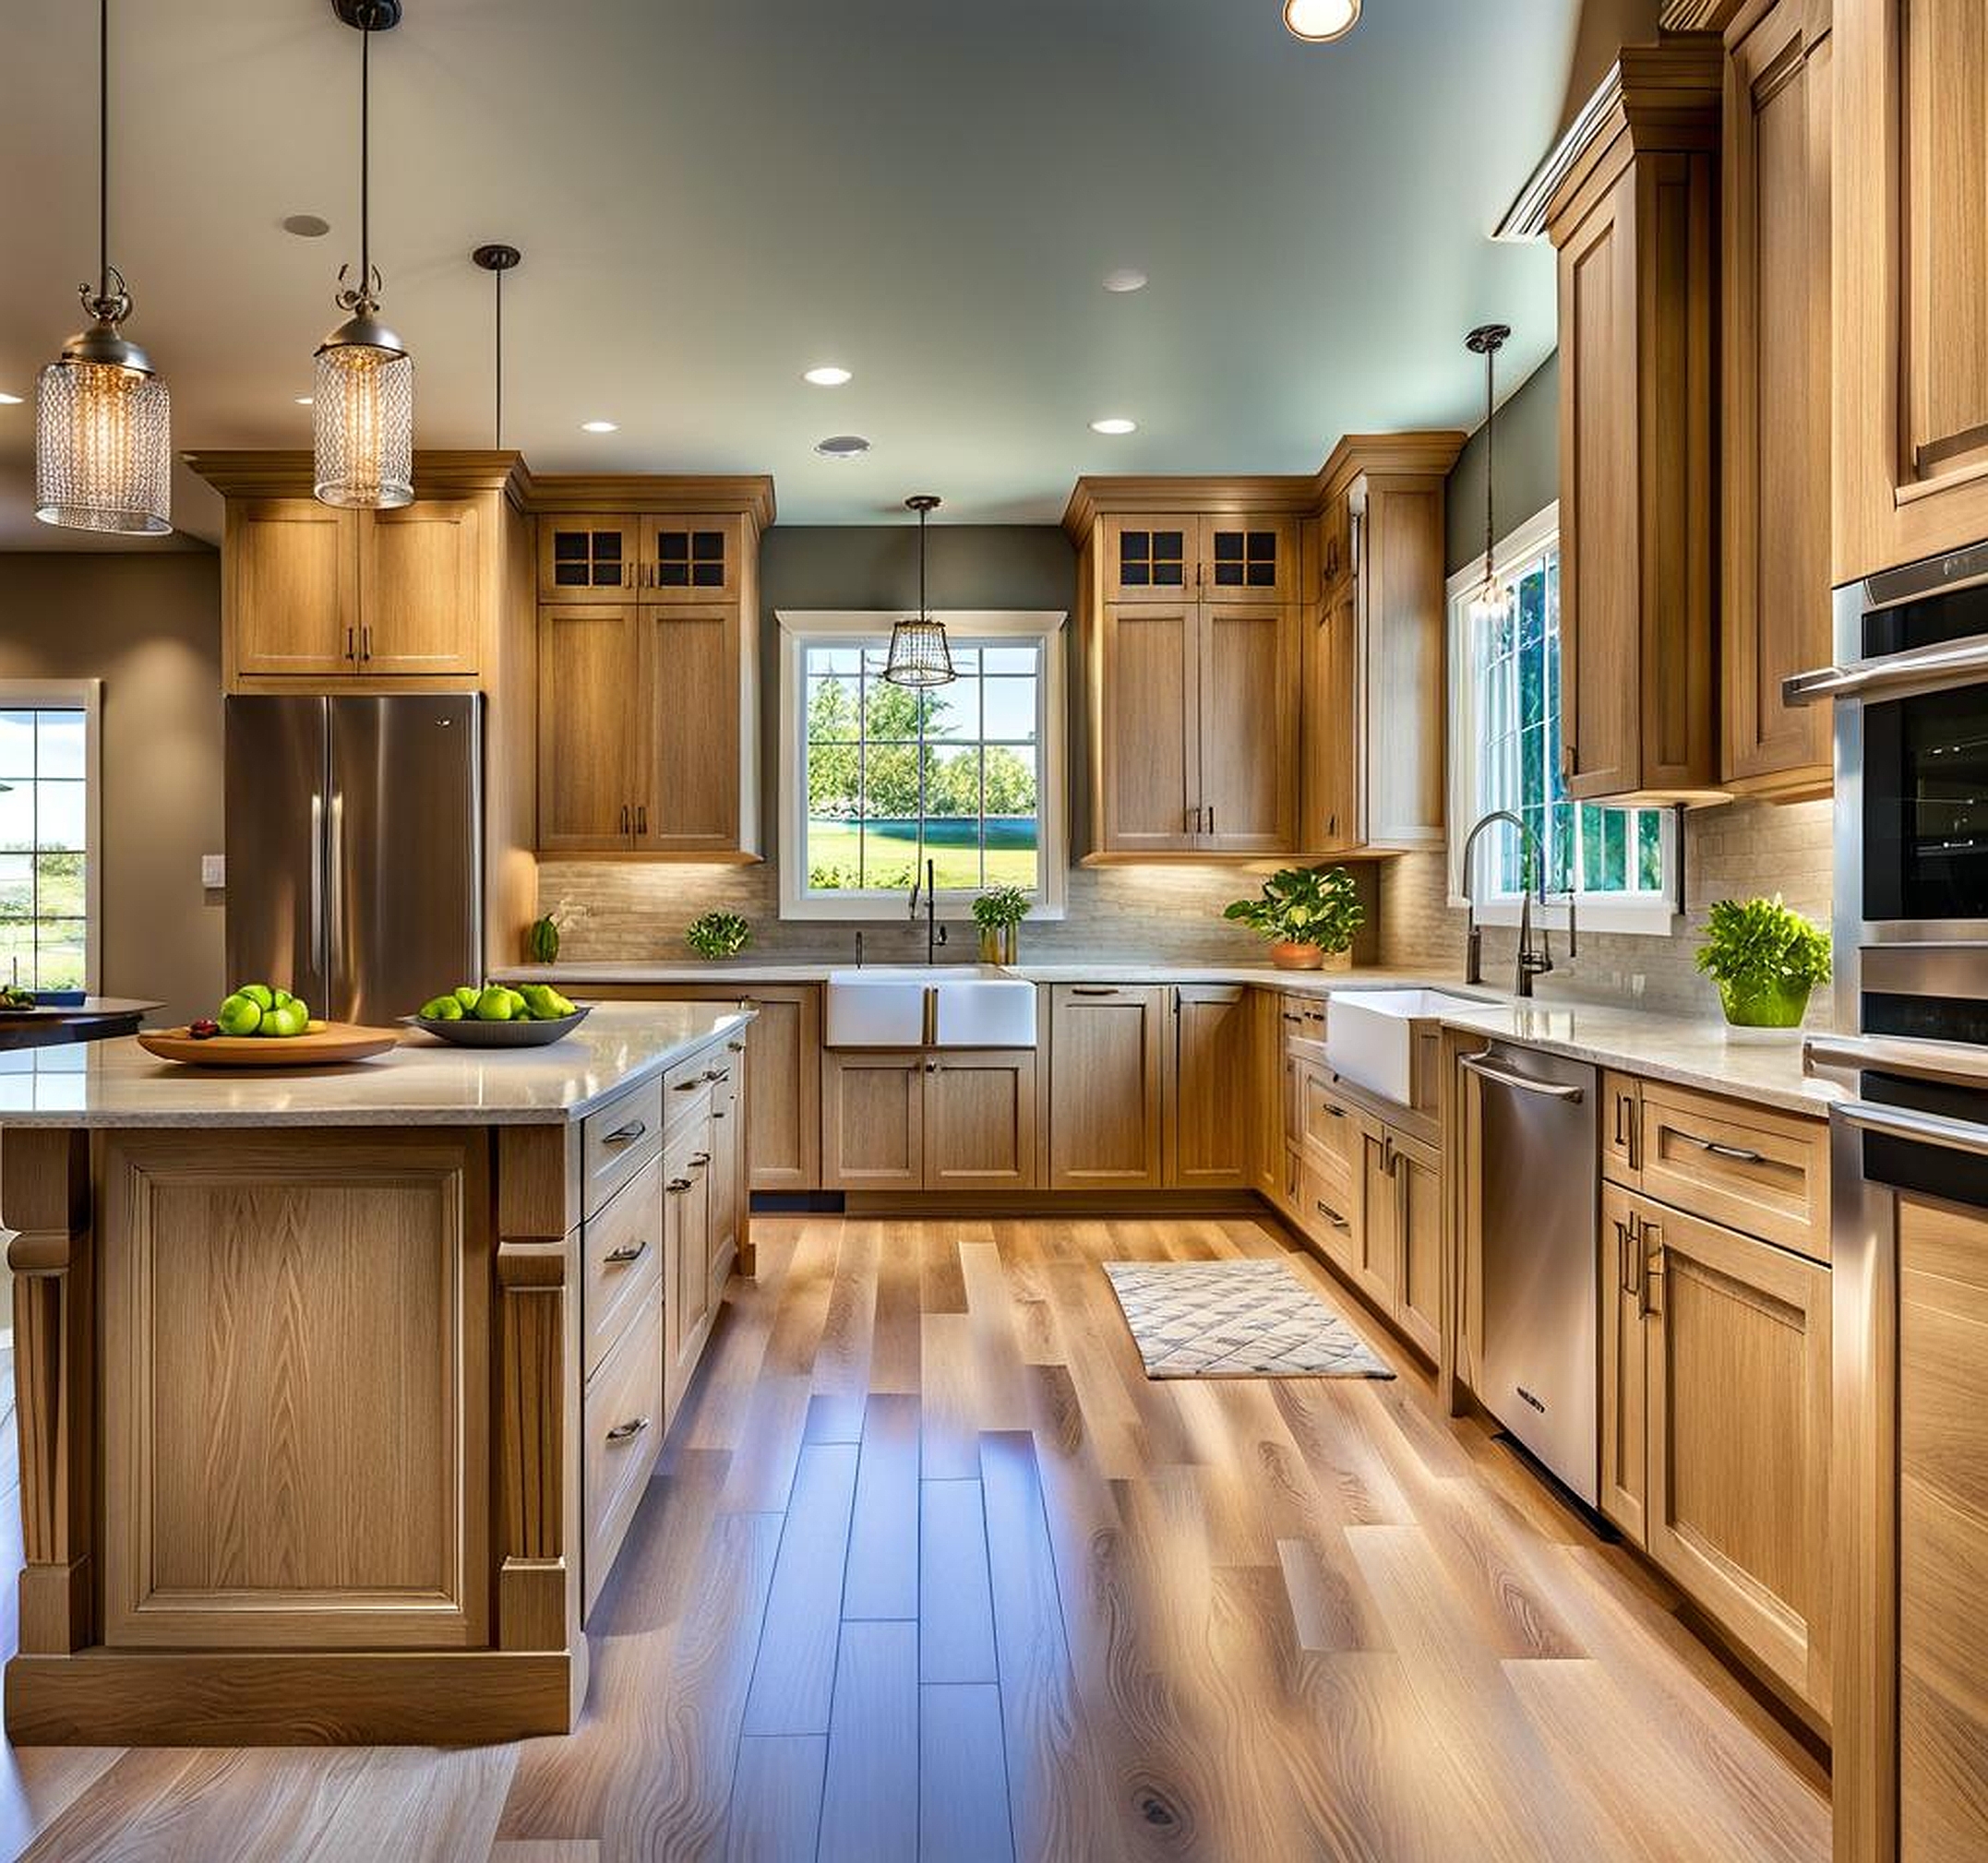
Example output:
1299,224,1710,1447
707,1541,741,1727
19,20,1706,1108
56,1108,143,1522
1831,0,1988,582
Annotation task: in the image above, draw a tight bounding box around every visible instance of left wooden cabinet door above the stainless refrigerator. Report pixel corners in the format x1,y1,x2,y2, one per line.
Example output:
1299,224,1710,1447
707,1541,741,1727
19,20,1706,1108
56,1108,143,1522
227,499,360,678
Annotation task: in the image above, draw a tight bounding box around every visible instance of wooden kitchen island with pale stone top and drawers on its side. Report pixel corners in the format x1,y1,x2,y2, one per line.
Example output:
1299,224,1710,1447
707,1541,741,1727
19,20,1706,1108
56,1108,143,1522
0,1004,751,1746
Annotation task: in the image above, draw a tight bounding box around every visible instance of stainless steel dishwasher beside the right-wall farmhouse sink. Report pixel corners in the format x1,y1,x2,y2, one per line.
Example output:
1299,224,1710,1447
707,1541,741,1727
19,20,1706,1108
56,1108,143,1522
1463,1042,1600,1507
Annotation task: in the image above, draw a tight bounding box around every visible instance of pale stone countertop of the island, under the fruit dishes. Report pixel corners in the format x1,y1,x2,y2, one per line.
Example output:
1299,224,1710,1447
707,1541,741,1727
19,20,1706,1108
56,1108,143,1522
0,1002,751,1128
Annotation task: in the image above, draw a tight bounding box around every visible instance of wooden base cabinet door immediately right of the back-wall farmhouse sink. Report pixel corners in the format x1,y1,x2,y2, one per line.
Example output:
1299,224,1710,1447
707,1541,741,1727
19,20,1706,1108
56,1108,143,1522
1049,985,1167,1191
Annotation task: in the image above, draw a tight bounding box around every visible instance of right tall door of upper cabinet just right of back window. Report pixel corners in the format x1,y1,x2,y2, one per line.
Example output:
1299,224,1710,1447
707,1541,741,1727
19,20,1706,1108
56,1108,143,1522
1191,603,1299,853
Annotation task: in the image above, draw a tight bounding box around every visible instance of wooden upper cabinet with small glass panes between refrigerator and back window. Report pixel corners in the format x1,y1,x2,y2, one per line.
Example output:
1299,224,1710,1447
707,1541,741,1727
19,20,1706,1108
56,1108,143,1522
533,477,773,861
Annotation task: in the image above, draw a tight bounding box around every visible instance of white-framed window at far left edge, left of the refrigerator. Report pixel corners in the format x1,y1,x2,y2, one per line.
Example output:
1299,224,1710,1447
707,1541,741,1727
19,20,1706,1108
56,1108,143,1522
0,680,98,990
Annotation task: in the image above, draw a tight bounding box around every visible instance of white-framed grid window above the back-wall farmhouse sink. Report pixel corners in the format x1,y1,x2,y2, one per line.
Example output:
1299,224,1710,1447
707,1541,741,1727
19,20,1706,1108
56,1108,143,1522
779,613,1066,918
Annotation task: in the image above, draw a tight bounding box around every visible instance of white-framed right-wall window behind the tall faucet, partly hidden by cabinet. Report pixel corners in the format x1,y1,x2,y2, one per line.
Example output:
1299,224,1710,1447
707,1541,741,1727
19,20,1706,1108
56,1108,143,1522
1449,505,1678,935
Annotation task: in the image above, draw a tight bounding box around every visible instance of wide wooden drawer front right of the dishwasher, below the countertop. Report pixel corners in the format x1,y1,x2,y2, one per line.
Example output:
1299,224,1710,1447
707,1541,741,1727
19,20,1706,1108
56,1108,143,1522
1638,1080,1829,1262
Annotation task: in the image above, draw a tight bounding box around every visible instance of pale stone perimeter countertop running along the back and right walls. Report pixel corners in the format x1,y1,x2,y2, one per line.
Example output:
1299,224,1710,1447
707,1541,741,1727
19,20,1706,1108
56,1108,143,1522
505,956,1845,1117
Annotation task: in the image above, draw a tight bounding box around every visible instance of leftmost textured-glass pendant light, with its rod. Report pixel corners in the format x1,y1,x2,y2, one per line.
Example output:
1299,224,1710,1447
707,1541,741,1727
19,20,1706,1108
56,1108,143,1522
34,0,173,537
